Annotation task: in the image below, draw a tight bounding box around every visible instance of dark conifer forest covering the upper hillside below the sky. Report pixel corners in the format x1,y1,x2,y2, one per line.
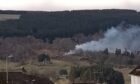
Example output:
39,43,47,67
0,9,140,40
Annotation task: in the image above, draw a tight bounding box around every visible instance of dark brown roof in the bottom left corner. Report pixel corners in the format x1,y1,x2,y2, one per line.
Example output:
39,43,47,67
0,72,54,84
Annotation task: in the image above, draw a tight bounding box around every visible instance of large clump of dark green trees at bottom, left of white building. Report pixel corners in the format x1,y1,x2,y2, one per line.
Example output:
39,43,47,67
69,65,124,84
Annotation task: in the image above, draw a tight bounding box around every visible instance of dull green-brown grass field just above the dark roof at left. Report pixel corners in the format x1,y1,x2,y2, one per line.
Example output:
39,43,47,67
0,60,73,81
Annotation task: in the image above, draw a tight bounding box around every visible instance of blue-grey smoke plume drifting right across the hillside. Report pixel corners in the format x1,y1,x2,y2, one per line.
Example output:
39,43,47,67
65,25,140,54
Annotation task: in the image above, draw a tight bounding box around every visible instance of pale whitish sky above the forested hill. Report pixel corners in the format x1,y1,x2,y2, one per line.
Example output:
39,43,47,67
0,0,140,11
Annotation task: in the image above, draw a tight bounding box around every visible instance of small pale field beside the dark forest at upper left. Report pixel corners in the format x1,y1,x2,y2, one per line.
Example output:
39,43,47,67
0,14,20,21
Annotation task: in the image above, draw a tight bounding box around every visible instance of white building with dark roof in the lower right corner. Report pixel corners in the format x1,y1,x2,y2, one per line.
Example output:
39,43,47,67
130,66,140,84
